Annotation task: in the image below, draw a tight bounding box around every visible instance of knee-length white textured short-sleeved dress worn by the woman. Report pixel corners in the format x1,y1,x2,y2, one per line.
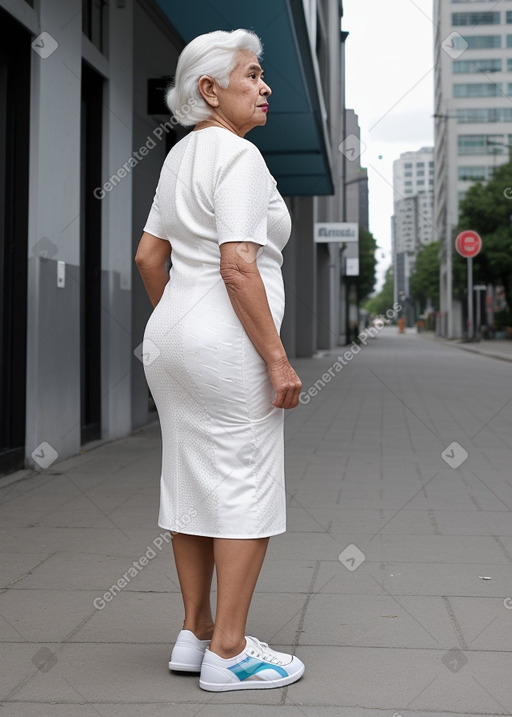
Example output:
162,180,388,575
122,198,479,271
143,127,291,538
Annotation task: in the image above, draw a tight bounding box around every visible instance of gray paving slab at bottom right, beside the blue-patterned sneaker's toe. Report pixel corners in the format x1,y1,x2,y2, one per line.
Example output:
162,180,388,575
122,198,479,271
289,643,512,715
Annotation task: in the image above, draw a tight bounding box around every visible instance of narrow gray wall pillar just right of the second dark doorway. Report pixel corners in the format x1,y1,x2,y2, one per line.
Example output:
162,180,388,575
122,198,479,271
101,0,134,440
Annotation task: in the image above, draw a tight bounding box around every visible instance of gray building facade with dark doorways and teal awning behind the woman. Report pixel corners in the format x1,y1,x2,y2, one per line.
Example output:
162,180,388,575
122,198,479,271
0,0,352,472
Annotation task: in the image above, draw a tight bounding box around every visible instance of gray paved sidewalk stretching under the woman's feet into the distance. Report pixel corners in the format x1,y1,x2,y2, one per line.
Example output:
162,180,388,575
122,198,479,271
0,327,512,717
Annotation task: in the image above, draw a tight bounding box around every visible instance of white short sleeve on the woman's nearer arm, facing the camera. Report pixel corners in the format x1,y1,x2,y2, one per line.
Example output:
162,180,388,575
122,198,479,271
213,141,272,246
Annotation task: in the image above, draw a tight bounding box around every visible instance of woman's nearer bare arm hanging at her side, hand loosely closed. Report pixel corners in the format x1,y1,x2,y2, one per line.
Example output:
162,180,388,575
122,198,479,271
220,242,302,408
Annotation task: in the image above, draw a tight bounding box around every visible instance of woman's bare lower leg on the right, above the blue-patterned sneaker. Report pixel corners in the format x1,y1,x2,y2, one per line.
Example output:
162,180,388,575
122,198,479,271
210,538,269,658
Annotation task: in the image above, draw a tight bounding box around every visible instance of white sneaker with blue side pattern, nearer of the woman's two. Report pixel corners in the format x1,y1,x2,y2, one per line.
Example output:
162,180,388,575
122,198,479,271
199,635,305,692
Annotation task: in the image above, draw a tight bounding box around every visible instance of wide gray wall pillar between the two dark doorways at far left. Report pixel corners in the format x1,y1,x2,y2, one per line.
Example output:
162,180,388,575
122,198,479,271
26,0,82,463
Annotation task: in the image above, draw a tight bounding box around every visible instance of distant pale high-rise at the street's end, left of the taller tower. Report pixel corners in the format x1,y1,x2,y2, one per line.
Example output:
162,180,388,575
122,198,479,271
391,147,437,310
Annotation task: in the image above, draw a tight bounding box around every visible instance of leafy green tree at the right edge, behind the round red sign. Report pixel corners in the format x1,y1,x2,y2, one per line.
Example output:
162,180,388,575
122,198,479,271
457,160,512,309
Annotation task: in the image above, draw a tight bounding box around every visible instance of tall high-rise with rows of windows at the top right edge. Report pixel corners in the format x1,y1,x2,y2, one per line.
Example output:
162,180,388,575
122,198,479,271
434,0,512,338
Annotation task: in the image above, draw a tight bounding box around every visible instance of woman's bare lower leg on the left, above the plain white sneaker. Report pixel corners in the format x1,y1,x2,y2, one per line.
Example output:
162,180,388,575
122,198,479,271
172,533,214,640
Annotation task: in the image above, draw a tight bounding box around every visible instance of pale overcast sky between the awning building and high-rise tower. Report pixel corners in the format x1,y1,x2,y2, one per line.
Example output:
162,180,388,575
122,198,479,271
343,0,434,285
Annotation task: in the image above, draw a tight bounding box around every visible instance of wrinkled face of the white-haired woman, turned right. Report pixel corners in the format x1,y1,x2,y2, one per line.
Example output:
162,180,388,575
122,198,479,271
212,50,272,137
